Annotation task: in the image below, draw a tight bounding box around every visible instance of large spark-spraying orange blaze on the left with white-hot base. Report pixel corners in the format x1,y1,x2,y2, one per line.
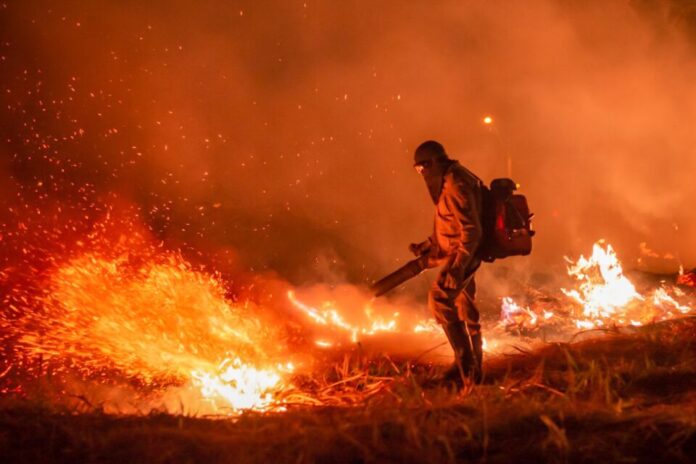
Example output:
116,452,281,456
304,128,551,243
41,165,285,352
10,248,293,412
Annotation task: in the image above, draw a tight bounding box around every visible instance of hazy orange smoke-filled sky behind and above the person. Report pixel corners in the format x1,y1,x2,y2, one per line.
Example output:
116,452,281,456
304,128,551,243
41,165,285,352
0,0,696,283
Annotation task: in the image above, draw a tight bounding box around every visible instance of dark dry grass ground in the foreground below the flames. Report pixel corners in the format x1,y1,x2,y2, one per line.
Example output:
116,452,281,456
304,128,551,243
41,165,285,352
0,317,696,463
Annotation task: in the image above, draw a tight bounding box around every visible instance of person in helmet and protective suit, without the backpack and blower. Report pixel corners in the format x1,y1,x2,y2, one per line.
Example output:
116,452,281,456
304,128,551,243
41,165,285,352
409,141,483,384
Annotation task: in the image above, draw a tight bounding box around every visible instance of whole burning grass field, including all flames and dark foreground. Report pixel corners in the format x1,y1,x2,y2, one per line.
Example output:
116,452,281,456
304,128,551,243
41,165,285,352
0,226,696,462
